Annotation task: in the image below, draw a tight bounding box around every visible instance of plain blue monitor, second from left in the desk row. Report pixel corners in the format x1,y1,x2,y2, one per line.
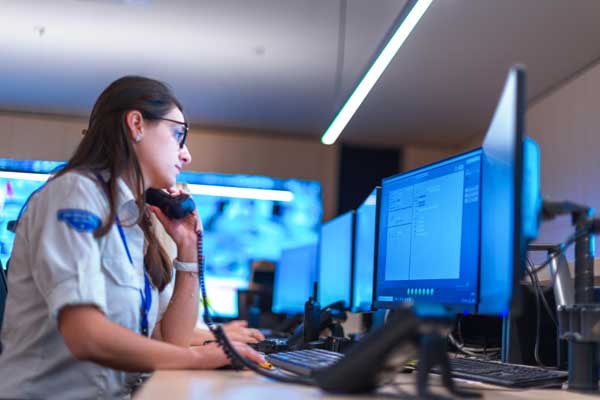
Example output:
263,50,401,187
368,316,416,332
317,211,355,310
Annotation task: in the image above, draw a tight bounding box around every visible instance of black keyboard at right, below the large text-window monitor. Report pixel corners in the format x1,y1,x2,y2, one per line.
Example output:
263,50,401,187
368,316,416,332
442,358,568,387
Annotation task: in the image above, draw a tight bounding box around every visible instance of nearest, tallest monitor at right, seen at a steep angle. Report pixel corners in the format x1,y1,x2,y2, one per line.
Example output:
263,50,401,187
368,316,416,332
479,68,527,315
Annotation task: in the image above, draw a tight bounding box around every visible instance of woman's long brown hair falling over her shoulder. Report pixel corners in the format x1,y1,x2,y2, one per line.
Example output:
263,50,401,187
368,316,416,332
57,76,183,291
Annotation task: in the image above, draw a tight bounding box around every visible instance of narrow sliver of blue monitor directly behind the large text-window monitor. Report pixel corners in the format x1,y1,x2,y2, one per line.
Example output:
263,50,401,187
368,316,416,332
352,187,381,312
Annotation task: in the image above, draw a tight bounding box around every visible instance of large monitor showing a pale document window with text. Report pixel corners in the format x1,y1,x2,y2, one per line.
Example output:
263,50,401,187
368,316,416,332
374,149,482,313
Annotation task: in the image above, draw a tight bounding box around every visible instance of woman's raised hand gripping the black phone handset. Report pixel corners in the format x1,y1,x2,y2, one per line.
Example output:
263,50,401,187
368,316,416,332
148,187,203,262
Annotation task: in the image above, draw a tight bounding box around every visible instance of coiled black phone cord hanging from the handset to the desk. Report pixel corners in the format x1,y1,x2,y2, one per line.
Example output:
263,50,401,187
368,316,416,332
198,232,315,385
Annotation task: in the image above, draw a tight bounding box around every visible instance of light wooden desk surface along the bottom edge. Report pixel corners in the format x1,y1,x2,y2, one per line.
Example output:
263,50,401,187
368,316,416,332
134,371,599,400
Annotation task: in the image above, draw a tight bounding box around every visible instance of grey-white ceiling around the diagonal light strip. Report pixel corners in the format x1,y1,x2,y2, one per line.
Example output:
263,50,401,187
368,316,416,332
0,0,600,146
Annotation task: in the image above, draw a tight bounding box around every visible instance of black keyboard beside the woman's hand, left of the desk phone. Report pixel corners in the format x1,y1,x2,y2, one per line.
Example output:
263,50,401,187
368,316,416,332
265,349,344,376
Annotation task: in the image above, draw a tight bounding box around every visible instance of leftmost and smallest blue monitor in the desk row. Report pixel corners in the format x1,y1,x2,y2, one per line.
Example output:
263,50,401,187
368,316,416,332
271,243,317,315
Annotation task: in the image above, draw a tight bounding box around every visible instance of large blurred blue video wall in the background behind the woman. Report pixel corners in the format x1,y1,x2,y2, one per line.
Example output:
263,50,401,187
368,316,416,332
0,159,322,317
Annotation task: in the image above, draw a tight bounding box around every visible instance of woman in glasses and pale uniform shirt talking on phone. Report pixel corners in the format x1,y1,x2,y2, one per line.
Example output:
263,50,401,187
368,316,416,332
0,77,263,399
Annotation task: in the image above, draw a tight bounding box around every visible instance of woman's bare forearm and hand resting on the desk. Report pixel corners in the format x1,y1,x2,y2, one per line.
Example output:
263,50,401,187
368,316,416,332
58,305,264,372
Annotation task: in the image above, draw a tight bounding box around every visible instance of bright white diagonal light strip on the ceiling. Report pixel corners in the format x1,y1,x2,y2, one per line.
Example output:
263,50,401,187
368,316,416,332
321,0,433,144
